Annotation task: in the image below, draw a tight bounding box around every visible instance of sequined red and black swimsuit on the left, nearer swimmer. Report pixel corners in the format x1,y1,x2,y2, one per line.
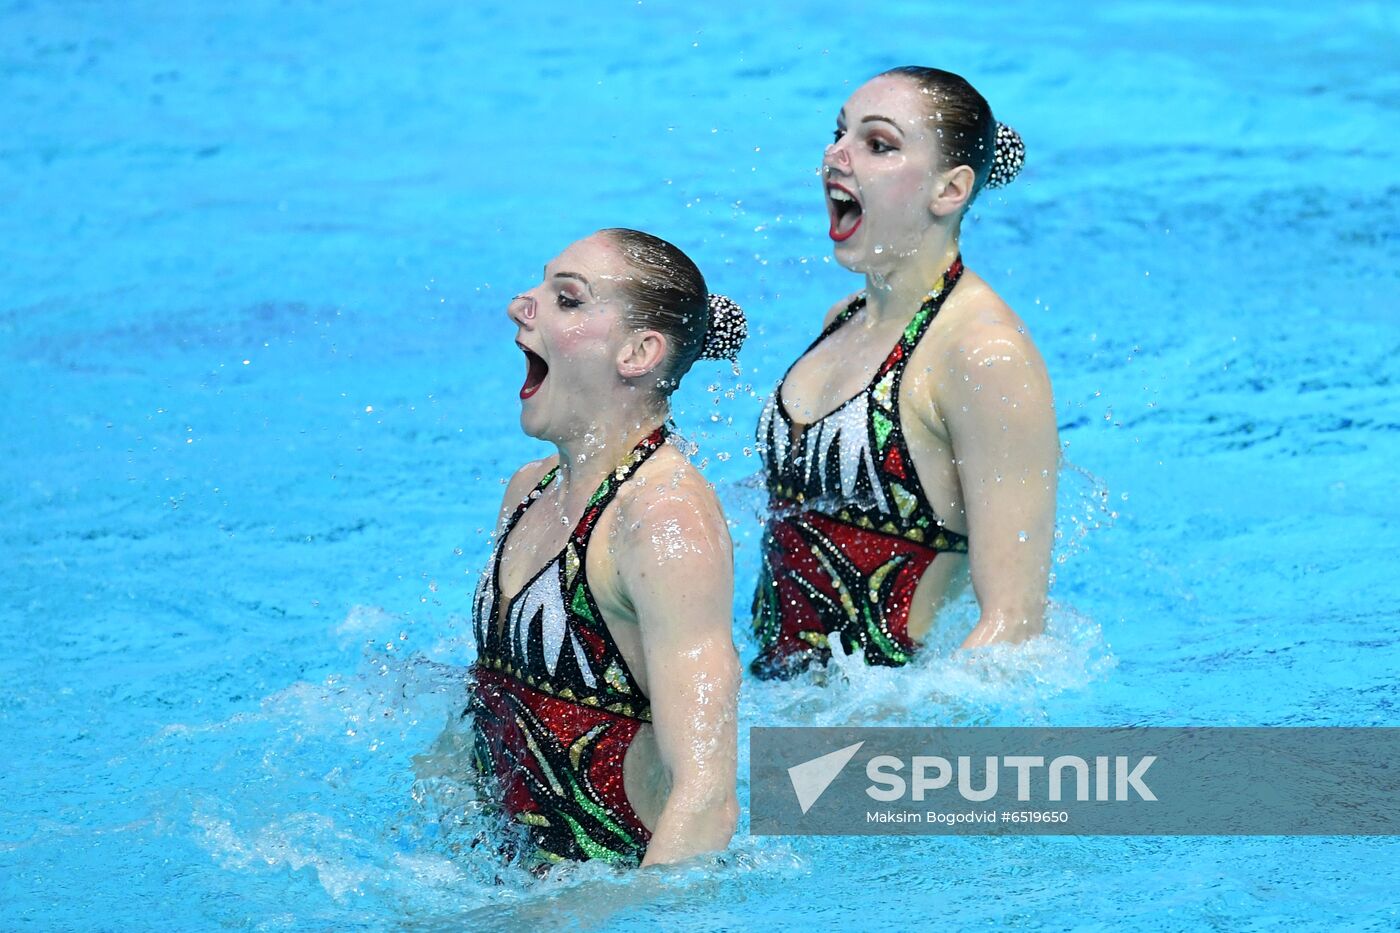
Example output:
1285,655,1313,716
468,427,668,863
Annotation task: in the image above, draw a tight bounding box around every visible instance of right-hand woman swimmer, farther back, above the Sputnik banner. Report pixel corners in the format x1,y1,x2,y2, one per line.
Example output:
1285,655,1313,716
753,67,1060,678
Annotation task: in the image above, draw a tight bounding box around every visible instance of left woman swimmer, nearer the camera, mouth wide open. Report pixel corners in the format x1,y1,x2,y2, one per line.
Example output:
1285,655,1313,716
466,230,746,866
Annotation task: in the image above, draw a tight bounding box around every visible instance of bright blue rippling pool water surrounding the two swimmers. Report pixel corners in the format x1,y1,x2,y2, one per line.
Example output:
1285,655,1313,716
0,0,1400,930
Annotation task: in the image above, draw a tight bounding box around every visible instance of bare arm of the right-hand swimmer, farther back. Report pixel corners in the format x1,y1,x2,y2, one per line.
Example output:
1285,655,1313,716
938,322,1060,649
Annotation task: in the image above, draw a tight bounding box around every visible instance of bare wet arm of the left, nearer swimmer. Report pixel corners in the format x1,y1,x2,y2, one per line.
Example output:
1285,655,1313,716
617,479,739,864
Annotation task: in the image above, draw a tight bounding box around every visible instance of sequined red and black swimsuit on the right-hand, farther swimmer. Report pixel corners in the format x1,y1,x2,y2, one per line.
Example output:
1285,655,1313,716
752,258,967,678
